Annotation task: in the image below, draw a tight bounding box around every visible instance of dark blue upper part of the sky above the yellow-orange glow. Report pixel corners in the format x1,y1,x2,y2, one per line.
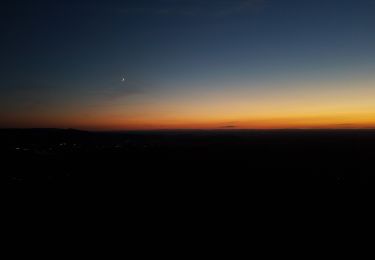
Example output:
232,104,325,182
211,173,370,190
0,0,375,128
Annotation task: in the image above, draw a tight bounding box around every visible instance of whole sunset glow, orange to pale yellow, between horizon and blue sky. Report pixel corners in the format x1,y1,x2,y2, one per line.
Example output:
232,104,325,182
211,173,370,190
0,76,375,130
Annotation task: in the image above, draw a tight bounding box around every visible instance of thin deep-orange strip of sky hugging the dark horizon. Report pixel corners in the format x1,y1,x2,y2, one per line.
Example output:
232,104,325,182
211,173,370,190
3,114,375,130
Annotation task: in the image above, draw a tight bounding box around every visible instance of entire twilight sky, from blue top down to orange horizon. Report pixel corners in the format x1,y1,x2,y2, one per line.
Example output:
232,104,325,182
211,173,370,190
0,0,375,130
